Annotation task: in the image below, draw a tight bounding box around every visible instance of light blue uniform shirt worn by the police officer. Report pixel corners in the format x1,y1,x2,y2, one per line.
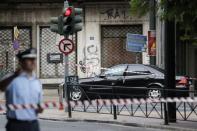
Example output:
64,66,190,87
6,73,42,121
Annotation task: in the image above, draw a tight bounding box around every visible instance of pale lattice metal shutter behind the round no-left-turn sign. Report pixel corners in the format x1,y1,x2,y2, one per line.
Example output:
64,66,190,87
39,26,77,78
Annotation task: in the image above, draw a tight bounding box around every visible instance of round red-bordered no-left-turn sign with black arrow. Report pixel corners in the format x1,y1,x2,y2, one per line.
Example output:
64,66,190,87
59,39,74,55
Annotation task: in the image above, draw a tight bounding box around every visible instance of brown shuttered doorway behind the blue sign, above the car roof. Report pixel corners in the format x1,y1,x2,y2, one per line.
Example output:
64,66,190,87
101,25,143,68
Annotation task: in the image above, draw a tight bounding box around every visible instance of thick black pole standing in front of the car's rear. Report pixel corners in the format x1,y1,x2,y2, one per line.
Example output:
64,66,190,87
165,1,176,122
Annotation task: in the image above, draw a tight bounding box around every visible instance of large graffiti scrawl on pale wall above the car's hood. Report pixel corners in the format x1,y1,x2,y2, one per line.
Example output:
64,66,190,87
79,37,100,77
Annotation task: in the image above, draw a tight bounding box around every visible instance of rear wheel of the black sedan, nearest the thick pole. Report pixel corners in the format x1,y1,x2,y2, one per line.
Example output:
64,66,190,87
147,86,162,99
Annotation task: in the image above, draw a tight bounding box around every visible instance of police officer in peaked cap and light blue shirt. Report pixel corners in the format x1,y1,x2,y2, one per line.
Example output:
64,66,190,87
6,49,43,131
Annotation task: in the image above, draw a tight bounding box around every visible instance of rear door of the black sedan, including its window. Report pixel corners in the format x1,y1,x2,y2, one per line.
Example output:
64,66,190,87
118,65,154,98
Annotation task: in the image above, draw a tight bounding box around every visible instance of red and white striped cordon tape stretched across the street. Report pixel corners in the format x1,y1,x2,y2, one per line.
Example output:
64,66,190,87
0,97,197,111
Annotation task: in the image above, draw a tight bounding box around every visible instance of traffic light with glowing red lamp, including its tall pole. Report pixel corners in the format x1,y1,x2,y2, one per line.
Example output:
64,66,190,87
50,0,83,118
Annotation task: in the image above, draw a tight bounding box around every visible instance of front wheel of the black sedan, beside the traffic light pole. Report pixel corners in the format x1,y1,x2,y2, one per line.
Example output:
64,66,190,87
70,86,84,101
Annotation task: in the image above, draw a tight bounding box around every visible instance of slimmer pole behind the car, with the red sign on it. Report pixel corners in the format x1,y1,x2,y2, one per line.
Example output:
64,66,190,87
149,0,156,65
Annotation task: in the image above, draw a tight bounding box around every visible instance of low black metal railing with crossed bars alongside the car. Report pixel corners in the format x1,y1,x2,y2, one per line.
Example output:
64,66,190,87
65,84,197,121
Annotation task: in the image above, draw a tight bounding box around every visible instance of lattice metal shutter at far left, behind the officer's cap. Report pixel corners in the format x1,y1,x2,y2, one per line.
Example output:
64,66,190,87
0,26,32,76
